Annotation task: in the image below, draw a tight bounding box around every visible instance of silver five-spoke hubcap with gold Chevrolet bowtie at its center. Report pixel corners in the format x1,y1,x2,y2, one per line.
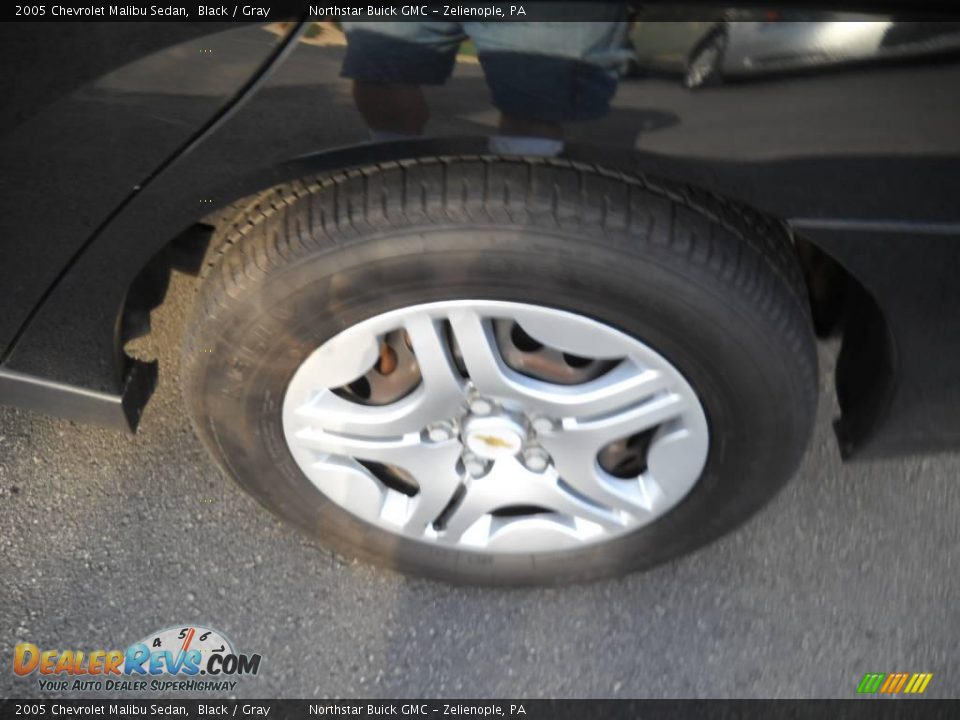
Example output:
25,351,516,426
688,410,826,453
283,300,709,553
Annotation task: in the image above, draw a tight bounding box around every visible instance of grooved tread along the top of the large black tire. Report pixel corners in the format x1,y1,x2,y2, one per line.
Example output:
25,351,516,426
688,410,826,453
191,156,816,410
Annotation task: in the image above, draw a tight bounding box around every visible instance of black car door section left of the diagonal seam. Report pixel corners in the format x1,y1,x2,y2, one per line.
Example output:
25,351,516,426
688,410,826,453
0,23,278,358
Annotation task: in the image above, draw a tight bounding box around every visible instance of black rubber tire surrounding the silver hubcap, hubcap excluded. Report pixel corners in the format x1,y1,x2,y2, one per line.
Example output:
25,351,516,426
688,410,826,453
182,157,817,585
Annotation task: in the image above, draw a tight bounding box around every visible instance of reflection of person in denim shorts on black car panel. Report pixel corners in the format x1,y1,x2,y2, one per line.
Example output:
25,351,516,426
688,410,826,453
342,15,627,155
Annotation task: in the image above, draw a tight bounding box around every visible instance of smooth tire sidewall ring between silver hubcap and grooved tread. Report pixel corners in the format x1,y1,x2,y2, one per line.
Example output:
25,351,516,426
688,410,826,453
189,227,815,584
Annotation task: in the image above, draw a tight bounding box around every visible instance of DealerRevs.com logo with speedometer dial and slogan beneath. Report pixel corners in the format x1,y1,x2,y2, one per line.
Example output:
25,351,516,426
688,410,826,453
13,625,261,692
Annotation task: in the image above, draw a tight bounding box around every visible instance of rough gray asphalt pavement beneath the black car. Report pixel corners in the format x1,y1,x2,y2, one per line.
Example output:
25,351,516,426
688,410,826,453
0,270,960,697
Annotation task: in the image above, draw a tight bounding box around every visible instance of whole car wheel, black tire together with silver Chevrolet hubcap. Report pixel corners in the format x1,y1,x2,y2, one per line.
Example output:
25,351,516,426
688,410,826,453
183,158,817,584
